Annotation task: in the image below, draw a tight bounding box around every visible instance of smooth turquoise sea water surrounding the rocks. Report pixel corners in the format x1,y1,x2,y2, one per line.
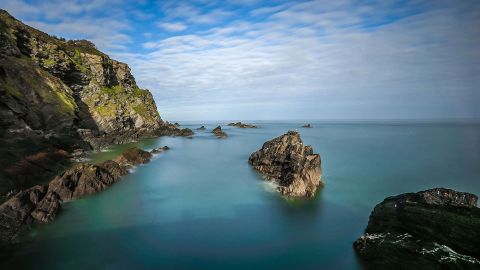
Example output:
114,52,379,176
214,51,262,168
0,122,480,269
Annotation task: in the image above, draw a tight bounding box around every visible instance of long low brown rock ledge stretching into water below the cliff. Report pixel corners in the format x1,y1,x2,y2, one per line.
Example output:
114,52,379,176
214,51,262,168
0,146,168,245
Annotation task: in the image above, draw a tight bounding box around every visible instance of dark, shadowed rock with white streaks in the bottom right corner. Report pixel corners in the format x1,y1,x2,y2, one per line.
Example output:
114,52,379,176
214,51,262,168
354,188,480,269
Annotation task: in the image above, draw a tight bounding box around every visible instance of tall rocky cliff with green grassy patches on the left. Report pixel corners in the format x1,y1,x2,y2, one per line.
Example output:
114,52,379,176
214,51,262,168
0,10,191,195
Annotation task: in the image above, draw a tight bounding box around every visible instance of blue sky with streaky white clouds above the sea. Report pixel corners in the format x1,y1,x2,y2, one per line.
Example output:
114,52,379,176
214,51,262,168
0,0,480,120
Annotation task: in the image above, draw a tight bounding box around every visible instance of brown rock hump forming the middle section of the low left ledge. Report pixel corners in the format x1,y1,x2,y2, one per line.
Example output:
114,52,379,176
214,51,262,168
48,159,127,202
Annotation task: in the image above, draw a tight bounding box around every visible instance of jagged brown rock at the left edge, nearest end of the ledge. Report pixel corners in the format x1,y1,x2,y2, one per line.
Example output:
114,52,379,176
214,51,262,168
0,185,61,244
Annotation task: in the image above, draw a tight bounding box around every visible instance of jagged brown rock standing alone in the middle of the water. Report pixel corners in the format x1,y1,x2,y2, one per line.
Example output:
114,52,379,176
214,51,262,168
248,131,323,197
